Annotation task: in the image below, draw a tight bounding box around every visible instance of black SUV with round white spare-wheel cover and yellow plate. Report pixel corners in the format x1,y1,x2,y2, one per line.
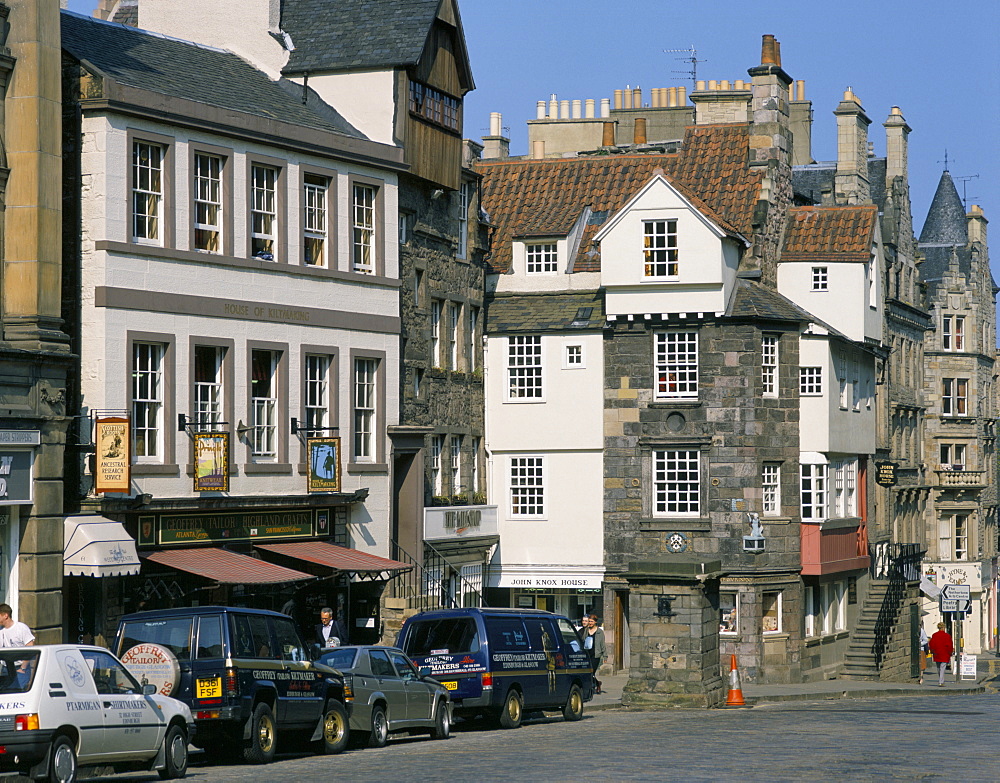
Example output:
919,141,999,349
113,606,350,764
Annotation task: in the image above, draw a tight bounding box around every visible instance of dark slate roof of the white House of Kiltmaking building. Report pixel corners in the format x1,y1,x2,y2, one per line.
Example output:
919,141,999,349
61,11,365,138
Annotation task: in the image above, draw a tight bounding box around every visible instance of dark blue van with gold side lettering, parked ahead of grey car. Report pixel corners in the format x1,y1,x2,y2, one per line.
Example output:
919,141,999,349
397,608,594,729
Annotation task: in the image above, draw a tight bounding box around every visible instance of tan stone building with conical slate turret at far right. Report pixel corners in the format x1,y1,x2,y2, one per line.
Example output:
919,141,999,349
919,171,1000,654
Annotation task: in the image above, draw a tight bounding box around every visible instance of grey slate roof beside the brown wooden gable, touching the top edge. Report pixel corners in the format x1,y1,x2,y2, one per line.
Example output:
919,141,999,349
281,0,441,73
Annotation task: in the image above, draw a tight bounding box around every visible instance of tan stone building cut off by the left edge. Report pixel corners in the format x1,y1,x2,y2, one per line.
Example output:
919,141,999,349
0,0,71,643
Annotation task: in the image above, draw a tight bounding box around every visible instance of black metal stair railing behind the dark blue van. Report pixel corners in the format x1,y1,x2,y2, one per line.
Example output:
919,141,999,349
389,541,488,609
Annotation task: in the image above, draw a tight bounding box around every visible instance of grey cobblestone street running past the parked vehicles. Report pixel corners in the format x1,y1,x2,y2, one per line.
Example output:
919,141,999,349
90,694,1000,783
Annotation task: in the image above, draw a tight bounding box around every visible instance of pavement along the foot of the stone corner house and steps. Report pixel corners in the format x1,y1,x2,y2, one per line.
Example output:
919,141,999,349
585,653,1000,711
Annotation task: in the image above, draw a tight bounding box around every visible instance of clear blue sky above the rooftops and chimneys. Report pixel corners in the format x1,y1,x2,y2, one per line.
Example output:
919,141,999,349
70,0,1000,266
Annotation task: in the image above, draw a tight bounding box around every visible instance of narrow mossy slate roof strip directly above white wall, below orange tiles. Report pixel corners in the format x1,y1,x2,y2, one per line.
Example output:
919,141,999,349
486,291,605,333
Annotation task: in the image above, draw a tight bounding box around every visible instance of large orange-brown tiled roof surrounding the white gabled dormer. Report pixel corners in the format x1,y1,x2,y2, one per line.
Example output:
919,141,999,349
475,124,762,273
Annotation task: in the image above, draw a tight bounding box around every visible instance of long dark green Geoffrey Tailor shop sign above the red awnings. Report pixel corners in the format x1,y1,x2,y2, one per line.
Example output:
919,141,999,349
145,509,315,546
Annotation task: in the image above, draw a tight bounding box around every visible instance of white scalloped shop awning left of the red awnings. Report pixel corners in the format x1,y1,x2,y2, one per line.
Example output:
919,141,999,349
63,514,139,576
